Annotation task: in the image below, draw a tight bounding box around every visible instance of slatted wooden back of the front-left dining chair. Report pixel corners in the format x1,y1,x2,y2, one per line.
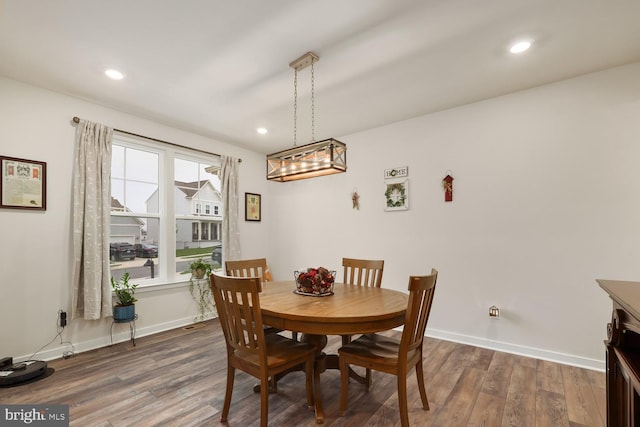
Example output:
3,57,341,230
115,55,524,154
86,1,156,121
211,274,266,361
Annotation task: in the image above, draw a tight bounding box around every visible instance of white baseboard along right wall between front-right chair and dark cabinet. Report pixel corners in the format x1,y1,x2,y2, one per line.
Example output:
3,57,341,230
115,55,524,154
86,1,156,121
425,328,606,372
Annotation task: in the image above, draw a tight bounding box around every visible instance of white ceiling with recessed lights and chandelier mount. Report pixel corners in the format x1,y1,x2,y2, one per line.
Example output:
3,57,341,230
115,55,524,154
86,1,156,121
0,0,640,153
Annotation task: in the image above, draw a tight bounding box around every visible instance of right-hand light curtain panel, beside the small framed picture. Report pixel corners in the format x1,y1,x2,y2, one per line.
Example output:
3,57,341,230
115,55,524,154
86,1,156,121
220,156,240,260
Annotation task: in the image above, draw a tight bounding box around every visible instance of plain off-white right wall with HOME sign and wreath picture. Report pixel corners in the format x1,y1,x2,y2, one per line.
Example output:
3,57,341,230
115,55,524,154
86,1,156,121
264,63,640,369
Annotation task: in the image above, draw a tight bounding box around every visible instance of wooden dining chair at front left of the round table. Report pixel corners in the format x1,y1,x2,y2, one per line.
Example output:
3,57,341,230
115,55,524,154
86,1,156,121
210,274,315,427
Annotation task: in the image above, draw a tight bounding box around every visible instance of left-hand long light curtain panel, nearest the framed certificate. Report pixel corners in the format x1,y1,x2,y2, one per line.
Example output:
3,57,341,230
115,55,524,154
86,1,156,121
71,120,113,320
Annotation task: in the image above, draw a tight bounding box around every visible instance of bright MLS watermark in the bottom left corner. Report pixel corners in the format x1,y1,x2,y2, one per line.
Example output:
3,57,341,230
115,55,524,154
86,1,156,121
0,405,69,427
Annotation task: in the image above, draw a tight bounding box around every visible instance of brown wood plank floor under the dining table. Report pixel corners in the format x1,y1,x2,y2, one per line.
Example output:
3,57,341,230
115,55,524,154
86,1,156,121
0,320,606,427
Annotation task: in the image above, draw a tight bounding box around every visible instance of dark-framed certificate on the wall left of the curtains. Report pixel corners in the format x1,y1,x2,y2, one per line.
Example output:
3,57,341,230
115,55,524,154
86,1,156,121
0,156,47,211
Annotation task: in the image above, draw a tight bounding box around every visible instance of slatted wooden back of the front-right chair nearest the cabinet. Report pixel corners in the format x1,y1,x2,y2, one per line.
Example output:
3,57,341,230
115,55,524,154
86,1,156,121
399,268,438,356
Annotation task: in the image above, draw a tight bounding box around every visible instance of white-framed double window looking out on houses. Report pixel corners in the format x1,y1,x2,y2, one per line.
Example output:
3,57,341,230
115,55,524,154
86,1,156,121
110,134,222,285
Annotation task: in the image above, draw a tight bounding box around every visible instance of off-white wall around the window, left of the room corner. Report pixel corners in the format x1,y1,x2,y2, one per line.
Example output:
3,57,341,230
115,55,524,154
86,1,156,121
0,78,267,360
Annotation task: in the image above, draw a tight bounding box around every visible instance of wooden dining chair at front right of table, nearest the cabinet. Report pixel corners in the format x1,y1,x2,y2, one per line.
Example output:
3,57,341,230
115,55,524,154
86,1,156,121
338,269,438,427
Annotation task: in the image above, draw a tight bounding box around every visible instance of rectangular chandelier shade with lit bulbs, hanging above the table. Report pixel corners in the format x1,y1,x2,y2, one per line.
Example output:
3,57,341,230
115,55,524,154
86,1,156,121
267,138,347,182
